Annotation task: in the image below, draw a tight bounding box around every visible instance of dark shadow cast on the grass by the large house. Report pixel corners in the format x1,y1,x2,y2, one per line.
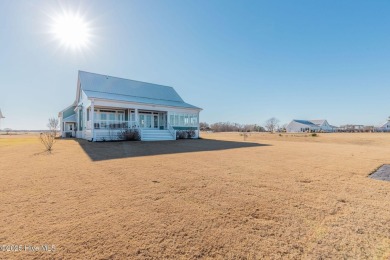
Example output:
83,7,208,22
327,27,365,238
75,139,269,161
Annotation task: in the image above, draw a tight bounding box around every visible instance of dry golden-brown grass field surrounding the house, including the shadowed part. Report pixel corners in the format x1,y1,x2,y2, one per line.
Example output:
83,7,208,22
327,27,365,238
0,133,390,259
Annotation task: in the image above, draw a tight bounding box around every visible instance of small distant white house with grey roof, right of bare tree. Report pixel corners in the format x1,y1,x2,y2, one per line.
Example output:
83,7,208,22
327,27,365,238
286,119,334,133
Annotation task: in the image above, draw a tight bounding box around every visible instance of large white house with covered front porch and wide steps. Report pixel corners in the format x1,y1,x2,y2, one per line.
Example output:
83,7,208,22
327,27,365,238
59,71,202,141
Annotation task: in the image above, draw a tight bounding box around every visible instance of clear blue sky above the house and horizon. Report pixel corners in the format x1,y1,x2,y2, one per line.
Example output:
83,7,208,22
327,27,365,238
0,0,390,129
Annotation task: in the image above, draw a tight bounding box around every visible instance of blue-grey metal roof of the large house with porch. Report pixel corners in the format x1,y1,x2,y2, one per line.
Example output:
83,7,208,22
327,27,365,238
79,71,200,109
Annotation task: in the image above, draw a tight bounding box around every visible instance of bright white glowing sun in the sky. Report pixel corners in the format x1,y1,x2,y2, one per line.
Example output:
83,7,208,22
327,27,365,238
52,13,90,49
